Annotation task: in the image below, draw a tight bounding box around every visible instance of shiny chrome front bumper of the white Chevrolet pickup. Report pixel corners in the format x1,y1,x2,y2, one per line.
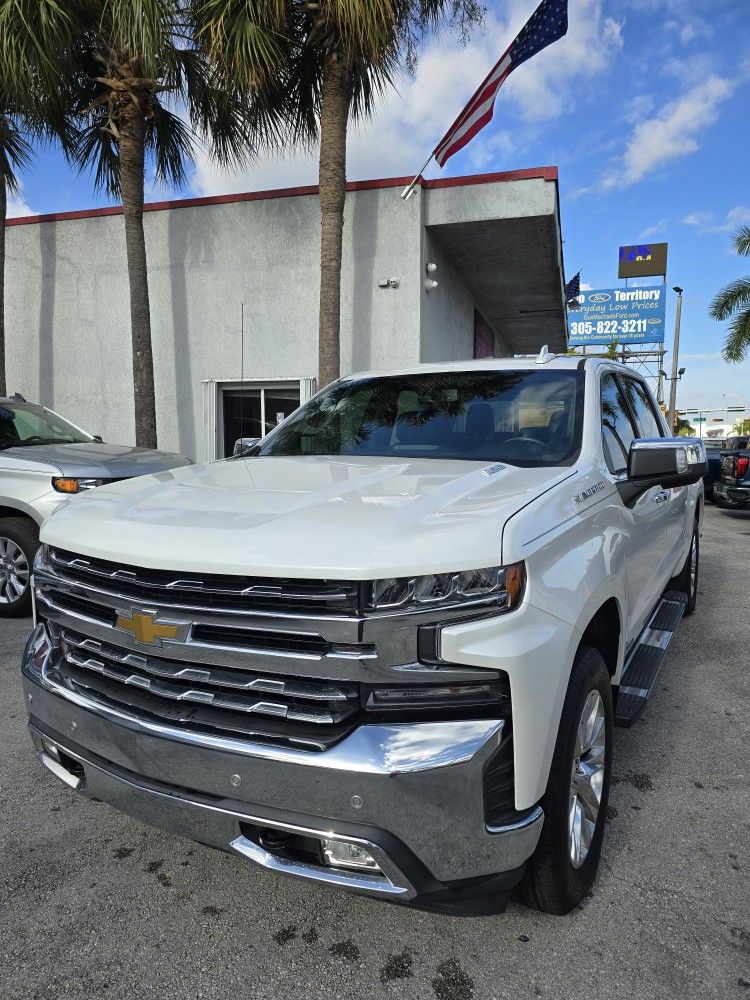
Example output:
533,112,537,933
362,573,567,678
23,643,543,900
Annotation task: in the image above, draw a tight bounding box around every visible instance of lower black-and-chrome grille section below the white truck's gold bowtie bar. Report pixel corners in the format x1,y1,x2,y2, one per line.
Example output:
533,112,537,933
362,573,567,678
58,628,360,749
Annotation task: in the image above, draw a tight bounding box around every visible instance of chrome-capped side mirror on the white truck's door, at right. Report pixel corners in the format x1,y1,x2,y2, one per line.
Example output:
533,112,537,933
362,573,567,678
621,438,708,503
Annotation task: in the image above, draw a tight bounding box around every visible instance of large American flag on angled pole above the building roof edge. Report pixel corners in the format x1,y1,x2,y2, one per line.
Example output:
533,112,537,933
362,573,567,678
434,0,568,167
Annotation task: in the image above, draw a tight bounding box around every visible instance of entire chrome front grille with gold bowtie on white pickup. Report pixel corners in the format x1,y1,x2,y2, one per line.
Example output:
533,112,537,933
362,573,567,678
34,548,506,750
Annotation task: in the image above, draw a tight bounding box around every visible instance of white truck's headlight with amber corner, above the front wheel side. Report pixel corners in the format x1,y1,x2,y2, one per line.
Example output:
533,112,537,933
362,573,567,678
369,563,526,611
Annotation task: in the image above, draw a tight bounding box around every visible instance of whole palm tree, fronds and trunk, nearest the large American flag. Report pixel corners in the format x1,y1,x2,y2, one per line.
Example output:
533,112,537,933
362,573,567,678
194,0,483,385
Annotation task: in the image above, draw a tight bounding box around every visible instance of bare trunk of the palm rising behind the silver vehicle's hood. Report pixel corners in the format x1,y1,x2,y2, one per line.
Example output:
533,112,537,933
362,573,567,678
120,102,156,448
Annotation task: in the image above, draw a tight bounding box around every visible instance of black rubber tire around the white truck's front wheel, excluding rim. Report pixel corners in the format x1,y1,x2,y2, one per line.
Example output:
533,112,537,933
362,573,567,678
520,645,613,914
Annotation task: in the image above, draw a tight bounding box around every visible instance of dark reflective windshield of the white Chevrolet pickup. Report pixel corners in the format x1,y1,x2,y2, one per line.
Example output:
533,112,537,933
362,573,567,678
258,370,583,467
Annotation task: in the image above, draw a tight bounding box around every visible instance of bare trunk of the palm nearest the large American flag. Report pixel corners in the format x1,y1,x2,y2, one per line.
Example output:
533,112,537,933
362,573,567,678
318,53,352,388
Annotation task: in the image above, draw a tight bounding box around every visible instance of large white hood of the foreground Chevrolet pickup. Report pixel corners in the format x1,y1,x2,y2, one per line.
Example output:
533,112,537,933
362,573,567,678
42,456,574,580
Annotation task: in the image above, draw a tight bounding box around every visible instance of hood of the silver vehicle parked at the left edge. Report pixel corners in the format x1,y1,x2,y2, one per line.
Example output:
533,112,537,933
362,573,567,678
0,441,189,479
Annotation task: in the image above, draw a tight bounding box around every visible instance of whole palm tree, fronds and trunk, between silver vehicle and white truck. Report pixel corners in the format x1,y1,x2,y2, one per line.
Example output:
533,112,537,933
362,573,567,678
54,0,258,448
